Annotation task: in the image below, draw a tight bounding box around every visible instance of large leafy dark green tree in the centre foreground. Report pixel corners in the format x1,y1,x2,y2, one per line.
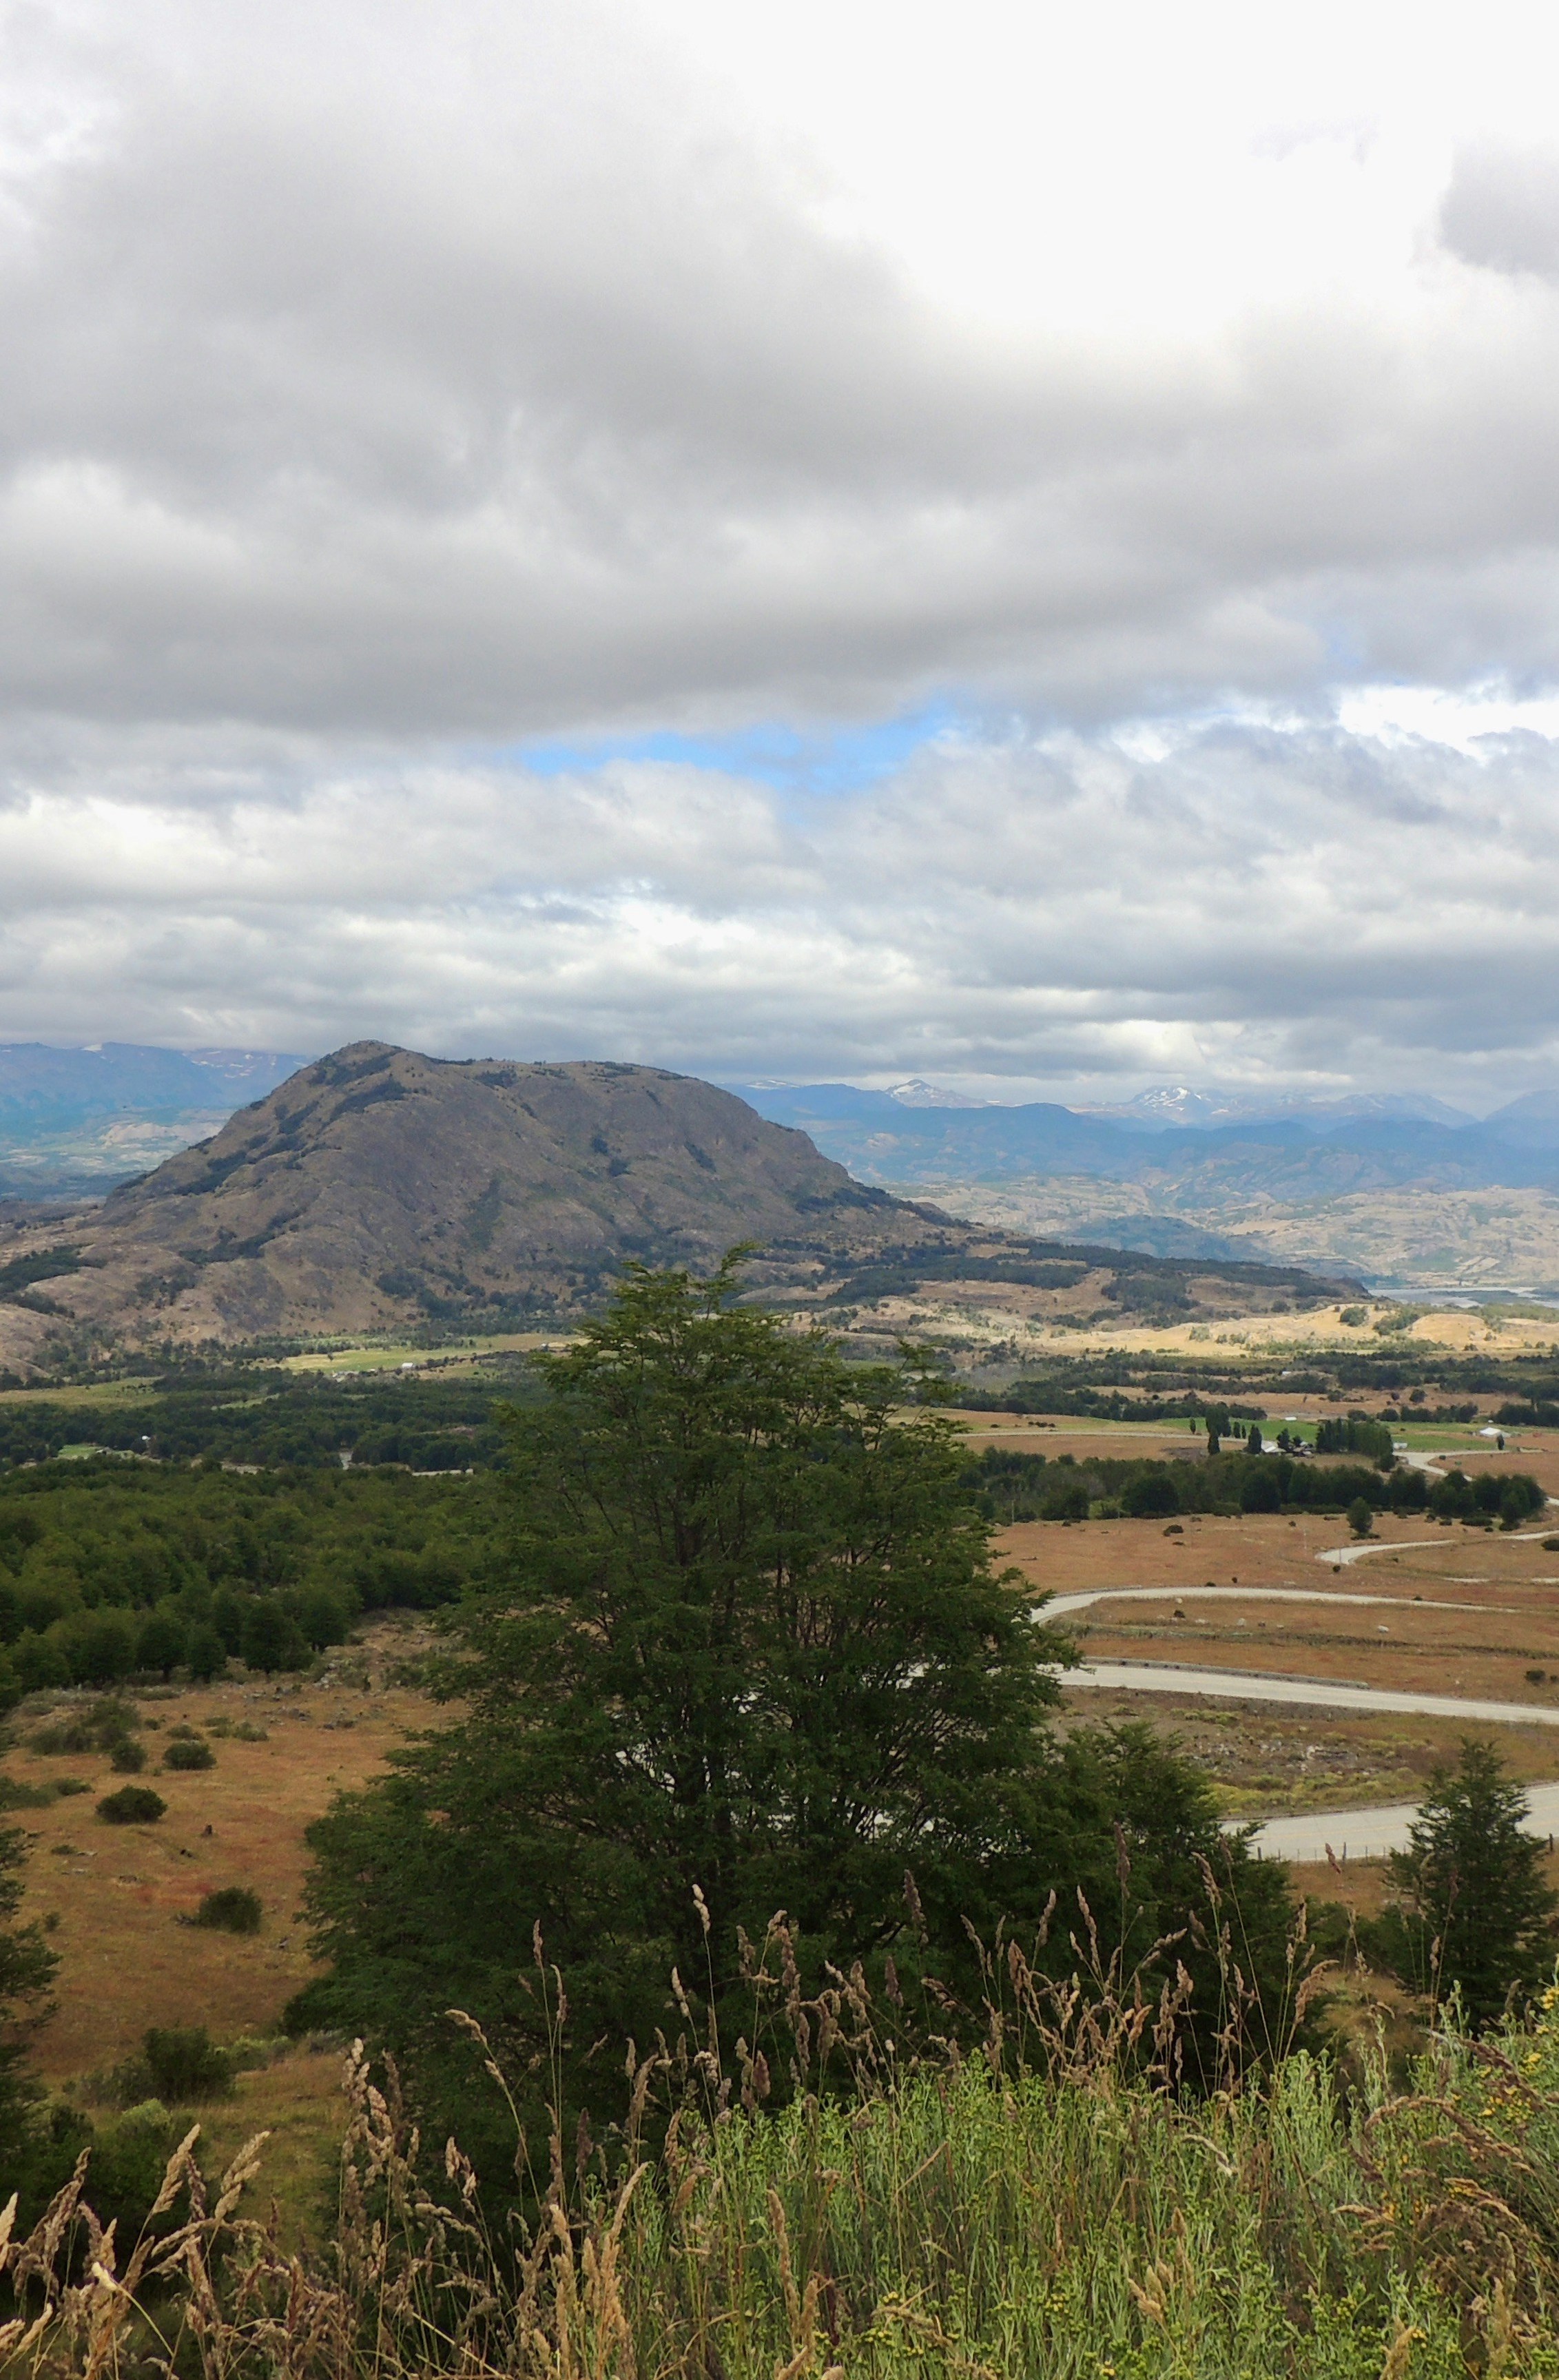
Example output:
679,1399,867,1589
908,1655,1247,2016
295,1266,1276,2161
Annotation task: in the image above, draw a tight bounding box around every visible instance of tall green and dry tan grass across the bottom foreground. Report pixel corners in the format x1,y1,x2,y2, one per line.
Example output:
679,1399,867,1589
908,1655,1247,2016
0,1925,1559,2380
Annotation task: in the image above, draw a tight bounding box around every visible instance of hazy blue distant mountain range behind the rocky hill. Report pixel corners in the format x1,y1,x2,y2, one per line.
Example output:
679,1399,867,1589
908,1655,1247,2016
0,1042,1559,1290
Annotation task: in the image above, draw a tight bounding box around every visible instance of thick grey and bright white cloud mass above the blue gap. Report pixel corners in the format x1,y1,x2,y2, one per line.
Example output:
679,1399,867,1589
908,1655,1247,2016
0,0,1559,738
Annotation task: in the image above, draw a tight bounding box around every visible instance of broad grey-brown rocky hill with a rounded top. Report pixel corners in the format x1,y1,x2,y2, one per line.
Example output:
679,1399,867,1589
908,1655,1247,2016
0,1042,1335,1369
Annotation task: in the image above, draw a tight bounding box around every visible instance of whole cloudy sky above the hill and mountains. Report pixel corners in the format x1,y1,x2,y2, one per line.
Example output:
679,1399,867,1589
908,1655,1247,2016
0,0,1559,1111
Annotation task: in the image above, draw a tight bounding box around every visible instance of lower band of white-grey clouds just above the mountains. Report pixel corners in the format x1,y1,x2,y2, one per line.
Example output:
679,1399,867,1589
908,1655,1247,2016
0,705,1559,1107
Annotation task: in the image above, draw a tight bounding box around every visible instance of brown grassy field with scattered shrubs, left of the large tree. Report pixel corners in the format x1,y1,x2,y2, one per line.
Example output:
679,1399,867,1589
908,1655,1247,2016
5,1628,431,2087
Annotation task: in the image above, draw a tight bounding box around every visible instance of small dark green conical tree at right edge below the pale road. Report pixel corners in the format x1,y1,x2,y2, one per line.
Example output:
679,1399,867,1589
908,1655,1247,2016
1390,1737,1559,2025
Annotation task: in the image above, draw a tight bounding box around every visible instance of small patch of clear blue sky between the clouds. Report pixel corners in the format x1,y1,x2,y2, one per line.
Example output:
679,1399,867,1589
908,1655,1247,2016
502,702,967,795
